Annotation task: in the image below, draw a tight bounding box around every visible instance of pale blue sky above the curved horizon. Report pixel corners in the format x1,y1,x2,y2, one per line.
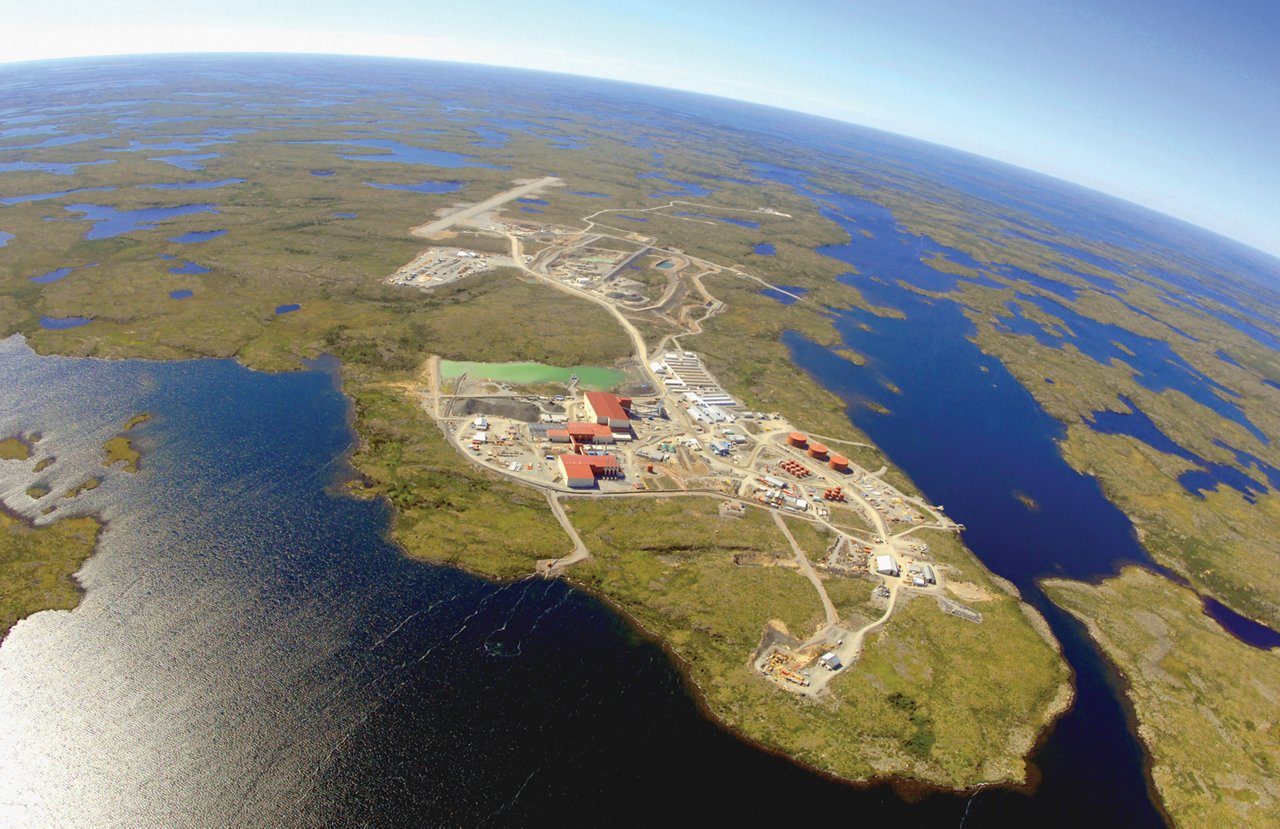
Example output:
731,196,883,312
0,0,1280,256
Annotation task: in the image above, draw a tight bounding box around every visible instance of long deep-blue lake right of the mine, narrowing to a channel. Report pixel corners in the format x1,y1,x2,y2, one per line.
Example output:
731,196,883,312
752,165,1161,825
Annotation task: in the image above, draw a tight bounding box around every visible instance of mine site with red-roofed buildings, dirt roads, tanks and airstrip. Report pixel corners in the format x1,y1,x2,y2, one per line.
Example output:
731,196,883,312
388,178,967,696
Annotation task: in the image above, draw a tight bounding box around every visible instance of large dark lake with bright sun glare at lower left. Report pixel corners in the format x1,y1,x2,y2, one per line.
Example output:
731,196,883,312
0,338,1152,826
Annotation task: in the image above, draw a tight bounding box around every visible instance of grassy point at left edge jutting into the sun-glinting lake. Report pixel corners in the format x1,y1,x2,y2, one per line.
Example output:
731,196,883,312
0,510,101,637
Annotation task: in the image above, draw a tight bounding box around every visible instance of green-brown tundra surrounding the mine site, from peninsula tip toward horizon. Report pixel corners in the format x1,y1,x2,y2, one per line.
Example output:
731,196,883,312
0,88,1080,787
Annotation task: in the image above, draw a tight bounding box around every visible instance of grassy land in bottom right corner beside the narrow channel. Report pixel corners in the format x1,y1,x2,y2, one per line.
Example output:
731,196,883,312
1043,568,1280,826
